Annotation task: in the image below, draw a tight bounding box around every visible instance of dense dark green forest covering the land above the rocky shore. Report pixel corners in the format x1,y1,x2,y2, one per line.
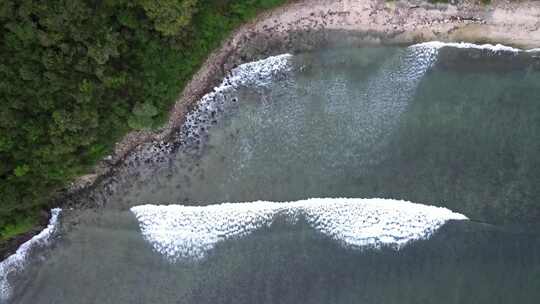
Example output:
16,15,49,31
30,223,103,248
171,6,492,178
0,0,285,240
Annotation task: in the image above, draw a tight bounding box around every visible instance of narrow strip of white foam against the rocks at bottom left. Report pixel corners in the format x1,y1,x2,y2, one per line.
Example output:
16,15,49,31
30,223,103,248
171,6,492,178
0,208,62,300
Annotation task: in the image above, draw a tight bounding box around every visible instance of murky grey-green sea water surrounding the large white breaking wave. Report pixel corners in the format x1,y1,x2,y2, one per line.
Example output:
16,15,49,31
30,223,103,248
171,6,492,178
0,43,540,304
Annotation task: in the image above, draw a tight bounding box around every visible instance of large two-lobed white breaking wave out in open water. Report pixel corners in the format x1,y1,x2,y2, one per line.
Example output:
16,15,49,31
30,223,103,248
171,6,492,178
131,198,467,262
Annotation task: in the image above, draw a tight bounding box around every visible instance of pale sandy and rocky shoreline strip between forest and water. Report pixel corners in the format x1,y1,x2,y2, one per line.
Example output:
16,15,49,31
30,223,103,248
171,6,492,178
0,0,540,260
